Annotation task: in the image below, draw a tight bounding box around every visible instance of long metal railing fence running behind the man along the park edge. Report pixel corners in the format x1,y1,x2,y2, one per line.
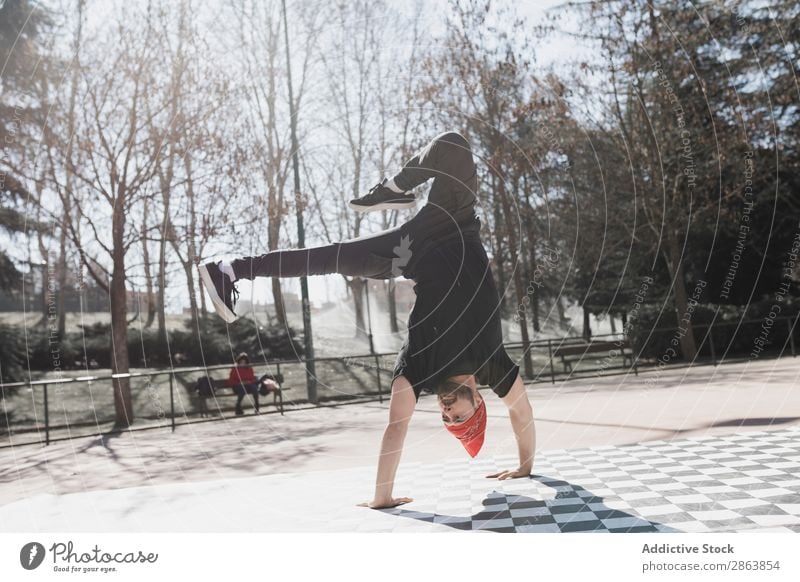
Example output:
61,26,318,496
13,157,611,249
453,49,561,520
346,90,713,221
0,316,798,447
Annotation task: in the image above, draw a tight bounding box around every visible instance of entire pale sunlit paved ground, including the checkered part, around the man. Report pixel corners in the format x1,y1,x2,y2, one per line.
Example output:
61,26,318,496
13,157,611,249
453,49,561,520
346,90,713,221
0,358,800,531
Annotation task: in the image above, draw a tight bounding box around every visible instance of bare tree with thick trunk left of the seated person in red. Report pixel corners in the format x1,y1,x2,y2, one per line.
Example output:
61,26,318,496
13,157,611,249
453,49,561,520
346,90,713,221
53,14,167,426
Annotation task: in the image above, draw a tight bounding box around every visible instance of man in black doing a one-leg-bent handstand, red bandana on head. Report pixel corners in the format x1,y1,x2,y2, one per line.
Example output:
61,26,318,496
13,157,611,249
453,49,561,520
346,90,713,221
200,131,536,509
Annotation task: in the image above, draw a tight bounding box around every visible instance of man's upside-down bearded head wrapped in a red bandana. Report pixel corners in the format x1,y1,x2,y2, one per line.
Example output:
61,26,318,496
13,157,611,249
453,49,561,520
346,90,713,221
437,374,486,457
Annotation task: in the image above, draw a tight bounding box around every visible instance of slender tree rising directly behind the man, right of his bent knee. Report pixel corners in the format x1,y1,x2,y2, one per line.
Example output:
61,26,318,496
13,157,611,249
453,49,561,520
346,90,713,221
418,0,533,377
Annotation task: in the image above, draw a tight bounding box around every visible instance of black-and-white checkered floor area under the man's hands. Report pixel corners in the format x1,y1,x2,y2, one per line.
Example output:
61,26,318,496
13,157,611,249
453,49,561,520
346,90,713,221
374,427,800,532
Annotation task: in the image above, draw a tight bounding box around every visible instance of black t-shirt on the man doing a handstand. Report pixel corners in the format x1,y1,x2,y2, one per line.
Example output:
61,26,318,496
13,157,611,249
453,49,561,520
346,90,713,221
394,229,519,398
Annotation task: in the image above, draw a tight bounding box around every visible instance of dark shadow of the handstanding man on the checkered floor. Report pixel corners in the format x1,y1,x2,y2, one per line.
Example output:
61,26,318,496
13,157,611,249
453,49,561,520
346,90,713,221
388,475,679,533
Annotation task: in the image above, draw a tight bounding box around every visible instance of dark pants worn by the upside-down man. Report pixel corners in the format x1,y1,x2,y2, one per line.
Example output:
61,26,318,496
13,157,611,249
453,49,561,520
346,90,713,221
231,132,477,286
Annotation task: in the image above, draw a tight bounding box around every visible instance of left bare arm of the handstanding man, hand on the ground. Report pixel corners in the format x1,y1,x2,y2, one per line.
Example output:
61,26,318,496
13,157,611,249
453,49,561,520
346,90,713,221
360,376,417,509
